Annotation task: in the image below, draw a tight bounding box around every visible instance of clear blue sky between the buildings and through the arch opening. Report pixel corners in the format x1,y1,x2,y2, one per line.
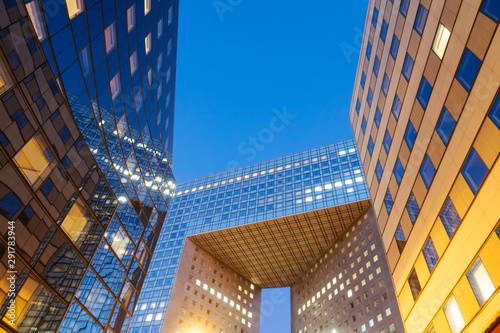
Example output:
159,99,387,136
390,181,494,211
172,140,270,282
173,0,368,333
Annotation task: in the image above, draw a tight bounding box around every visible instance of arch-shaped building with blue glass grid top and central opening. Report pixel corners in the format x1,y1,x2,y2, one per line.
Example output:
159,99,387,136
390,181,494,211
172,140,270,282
135,140,403,333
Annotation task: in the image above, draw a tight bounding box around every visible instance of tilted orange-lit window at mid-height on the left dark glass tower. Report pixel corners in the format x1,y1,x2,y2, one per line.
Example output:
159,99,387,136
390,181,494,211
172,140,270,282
14,134,55,185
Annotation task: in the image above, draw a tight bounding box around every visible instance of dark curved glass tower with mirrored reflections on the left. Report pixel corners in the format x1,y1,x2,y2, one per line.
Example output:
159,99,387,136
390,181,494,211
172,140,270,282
0,0,178,333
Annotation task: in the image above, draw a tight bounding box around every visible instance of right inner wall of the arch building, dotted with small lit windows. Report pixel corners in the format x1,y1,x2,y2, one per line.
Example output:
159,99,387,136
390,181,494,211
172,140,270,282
290,207,404,333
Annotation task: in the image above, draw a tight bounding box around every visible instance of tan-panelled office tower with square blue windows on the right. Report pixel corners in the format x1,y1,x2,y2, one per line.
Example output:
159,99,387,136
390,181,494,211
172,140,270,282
349,0,500,333
